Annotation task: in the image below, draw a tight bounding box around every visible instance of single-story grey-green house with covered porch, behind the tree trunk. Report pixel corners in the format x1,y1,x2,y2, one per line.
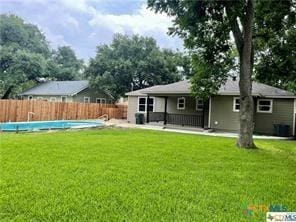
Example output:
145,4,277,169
126,79,296,136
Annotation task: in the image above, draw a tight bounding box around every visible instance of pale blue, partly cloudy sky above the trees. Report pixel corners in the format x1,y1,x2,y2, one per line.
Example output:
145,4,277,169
0,0,183,61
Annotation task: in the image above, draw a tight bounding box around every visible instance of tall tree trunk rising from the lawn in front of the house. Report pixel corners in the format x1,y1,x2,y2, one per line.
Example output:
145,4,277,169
237,0,255,148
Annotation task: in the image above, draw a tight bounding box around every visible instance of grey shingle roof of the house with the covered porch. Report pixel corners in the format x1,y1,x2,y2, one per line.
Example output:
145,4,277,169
126,79,296,98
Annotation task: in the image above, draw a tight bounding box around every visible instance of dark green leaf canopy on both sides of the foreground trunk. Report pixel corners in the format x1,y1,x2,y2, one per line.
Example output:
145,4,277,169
148,0,296,97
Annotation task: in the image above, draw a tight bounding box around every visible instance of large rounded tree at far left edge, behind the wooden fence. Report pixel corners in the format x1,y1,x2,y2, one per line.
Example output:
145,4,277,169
0,15,50,98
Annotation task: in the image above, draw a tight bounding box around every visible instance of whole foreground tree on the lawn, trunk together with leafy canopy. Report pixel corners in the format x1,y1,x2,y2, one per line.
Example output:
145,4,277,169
148,0,295,148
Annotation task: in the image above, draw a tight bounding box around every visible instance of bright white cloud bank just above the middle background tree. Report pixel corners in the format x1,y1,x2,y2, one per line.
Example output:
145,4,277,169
89,4,183,50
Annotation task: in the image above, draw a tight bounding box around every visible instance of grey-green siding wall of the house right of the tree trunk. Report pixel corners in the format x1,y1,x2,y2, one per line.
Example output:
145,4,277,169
254,99,294,135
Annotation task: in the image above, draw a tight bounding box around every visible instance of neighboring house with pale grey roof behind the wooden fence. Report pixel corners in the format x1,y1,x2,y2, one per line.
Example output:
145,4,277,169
20,80,114,104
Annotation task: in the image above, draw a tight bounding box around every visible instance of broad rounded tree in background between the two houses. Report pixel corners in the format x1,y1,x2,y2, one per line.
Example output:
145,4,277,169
85,34,188,98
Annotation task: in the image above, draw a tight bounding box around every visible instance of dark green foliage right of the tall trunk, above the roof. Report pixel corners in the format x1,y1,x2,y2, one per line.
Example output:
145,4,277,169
254,1,296,94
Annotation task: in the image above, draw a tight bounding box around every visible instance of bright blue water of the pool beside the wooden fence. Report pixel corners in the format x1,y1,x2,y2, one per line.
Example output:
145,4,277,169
0,120,104,131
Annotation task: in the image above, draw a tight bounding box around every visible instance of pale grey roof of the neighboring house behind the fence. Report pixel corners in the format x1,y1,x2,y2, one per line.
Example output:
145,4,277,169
21,80,89,96
